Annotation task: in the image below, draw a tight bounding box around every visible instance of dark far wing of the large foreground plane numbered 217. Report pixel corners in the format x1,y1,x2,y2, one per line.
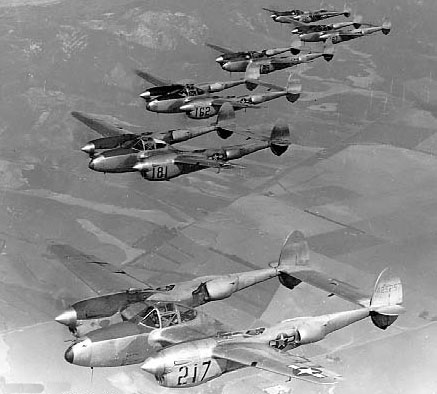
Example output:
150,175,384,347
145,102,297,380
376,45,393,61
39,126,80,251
48,244,151,294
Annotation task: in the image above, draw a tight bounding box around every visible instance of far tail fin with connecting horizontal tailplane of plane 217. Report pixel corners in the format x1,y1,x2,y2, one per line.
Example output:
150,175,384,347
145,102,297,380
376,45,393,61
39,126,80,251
278,231,371,307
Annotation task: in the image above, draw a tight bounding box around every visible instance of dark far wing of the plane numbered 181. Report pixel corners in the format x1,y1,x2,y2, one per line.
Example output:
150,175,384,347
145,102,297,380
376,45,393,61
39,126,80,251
71,111,146,137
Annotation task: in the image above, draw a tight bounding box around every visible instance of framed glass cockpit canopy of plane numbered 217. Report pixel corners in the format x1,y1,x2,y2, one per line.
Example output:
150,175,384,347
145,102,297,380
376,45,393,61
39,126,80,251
137,302,197,329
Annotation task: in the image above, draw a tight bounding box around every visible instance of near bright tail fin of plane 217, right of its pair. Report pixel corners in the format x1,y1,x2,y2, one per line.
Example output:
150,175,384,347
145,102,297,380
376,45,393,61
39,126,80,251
370,268,404,330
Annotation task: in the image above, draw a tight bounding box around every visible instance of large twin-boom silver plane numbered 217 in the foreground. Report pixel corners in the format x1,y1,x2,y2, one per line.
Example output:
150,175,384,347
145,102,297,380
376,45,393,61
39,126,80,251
55,231,404,388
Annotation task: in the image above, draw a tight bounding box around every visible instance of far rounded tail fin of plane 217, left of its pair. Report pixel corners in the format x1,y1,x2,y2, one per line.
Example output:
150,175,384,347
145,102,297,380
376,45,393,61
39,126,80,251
277,230,310,289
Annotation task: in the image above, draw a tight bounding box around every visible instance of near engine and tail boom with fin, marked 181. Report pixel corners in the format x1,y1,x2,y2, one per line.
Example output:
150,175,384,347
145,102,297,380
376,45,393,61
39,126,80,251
134,122,291,181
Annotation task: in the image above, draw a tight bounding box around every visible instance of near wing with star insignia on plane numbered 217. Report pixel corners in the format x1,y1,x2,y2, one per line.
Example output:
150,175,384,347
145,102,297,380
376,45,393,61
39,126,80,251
213,342,341,384
